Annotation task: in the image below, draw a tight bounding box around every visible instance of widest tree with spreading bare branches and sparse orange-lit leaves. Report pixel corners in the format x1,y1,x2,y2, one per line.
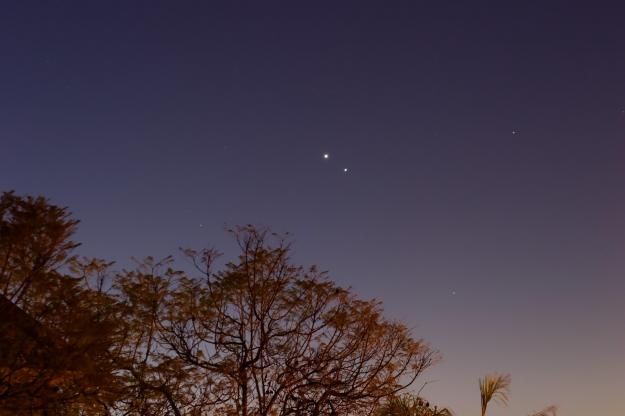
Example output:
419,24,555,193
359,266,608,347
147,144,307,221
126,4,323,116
145,226,437,416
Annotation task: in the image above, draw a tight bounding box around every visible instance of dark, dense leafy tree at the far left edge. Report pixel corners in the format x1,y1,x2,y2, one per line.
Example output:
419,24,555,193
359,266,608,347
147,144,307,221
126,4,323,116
0,192,116,414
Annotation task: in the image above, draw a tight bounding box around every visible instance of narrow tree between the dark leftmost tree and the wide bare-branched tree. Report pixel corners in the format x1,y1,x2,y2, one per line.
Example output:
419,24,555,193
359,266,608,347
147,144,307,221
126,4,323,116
115,257,205,416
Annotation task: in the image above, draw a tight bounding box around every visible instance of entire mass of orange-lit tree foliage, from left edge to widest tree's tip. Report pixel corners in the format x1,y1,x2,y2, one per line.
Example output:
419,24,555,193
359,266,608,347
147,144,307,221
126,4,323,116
0,193,438,416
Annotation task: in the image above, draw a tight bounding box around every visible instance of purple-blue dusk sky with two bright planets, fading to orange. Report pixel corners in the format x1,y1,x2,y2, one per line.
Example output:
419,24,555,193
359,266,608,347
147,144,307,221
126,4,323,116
0,0,625,416
